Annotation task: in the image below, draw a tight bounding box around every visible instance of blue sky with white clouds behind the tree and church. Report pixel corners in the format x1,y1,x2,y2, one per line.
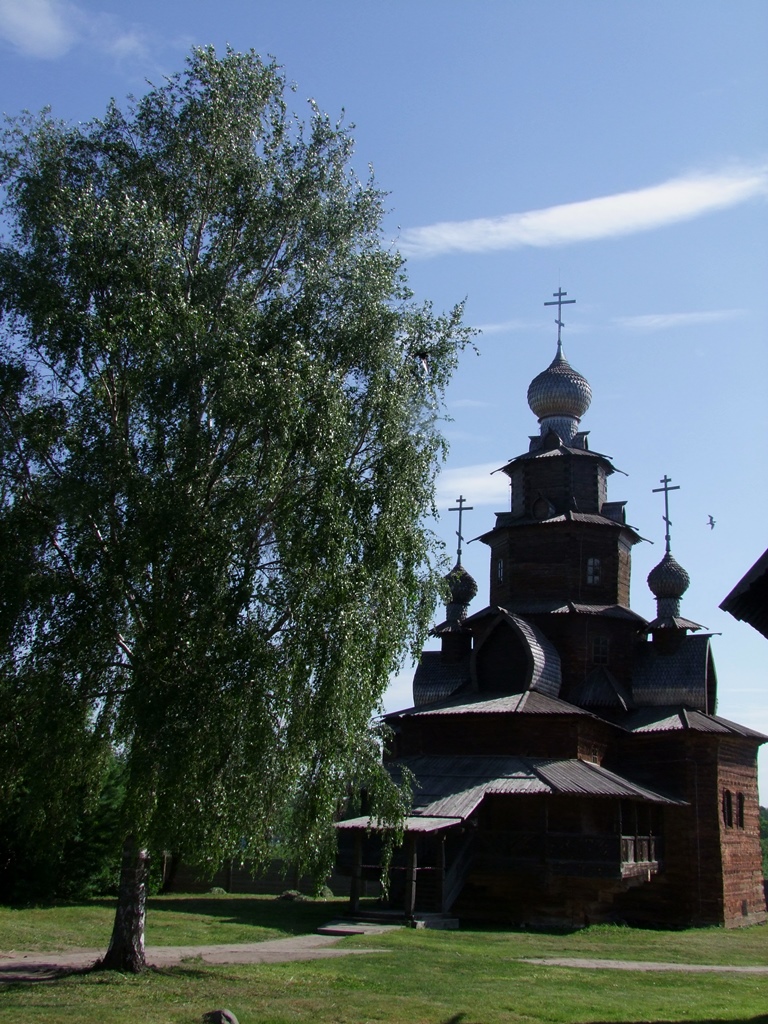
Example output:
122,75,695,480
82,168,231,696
0,0,768,790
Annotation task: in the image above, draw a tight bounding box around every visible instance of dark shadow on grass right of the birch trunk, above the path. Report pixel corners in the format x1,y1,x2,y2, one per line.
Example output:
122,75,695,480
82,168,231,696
146,896,348,935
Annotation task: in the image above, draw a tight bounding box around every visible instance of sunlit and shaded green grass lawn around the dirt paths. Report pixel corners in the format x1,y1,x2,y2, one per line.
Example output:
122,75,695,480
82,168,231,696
0,896,768,1024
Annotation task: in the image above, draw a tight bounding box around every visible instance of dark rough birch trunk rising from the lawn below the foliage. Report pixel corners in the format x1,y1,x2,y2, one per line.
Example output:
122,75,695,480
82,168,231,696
96,836,150,974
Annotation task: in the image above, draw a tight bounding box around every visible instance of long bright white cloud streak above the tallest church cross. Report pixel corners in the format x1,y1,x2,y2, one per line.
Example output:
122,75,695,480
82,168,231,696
399,164,768,257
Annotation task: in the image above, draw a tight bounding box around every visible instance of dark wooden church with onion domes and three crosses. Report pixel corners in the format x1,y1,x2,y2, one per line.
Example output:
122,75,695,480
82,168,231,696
337,291,768,927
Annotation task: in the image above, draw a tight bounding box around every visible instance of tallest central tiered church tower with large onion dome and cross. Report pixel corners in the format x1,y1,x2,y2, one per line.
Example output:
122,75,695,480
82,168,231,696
481,290,642,691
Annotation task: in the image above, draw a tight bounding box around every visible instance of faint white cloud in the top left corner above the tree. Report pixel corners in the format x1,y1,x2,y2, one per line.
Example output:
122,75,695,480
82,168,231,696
0,0,148,60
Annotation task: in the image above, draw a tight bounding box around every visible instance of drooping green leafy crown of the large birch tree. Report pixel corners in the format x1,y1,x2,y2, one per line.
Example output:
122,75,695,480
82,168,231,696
0,49,467,880
